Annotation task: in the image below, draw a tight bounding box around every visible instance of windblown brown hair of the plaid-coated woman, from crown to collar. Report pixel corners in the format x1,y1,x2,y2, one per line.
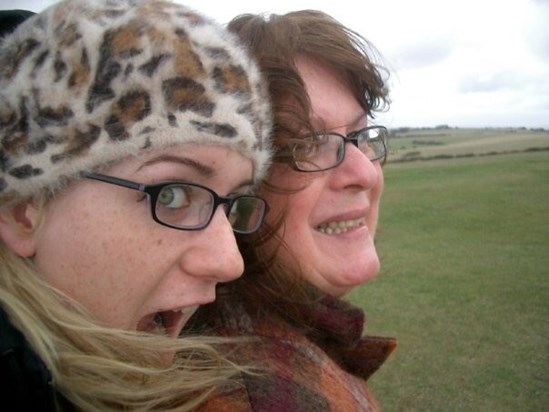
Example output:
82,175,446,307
193,10,390,327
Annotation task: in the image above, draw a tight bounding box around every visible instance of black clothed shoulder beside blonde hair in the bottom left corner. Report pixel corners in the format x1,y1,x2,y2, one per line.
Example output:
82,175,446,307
0,306,55,411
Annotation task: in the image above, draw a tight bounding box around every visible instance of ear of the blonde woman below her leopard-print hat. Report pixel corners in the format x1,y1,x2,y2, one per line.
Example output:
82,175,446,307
0,200,40,257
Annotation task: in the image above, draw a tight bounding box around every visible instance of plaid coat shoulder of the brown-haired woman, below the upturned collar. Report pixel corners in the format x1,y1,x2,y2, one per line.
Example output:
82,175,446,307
201,310,375,412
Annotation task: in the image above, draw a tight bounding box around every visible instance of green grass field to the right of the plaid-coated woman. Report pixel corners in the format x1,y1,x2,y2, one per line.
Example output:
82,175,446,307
349,136,549,412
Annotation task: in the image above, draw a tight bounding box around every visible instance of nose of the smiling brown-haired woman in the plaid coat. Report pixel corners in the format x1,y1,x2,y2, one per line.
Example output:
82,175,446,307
332,141,382,190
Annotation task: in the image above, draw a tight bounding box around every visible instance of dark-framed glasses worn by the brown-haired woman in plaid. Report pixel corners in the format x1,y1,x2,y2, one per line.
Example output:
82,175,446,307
290,126,389,172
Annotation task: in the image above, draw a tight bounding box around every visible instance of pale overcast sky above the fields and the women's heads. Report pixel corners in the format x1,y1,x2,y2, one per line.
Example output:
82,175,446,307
4,0,549,128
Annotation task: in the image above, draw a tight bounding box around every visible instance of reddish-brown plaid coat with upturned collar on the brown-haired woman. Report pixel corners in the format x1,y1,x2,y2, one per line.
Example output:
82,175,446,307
199,297,396,412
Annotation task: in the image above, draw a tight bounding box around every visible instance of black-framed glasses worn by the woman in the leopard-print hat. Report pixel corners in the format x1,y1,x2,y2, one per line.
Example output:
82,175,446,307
83,173,267,234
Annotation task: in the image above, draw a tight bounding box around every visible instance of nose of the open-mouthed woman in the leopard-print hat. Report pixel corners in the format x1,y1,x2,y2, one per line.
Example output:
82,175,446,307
182,207,244,282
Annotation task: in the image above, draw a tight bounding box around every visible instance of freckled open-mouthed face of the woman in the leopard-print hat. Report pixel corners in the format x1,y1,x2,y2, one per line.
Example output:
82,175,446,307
26,144,253,337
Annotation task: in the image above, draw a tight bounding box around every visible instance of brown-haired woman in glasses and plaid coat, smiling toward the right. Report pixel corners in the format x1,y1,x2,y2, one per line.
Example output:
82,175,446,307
193,11,396,411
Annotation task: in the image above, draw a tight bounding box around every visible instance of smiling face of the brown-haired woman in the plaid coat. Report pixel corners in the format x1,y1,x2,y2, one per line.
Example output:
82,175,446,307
262,58,383,296
